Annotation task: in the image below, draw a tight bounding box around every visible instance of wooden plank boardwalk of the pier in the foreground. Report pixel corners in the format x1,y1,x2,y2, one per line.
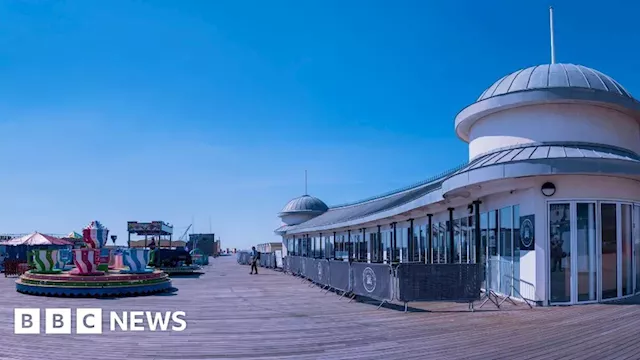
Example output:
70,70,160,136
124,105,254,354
0,257,640,360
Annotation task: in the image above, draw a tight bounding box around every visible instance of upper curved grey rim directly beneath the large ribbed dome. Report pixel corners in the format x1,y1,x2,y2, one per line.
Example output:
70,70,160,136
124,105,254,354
455,88,640,142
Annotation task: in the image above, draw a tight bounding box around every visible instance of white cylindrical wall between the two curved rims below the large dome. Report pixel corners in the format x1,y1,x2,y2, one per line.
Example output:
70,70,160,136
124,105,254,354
469,104,640,159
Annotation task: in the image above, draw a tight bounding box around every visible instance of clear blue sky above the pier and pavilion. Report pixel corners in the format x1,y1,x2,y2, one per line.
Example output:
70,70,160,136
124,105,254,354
0,0,640,247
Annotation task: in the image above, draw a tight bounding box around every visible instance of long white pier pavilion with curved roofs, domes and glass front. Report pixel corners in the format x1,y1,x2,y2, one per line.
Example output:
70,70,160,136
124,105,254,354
276,63,640,305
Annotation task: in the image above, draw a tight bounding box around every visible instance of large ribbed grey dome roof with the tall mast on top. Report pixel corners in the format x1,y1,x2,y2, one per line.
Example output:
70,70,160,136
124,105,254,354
478,64,633,101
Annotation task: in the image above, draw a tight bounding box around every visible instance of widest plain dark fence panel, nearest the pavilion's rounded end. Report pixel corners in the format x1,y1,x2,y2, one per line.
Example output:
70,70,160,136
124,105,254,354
397,264,482,302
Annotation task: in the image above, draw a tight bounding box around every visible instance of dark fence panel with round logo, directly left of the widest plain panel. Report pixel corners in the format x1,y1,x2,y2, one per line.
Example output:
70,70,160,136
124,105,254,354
351,263,393,301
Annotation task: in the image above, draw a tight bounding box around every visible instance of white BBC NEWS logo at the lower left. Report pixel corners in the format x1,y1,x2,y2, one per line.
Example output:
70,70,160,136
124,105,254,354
13,308,187,335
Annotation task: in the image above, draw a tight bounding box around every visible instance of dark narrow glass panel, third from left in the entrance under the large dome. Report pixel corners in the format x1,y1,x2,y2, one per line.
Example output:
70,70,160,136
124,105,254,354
600,204,618,299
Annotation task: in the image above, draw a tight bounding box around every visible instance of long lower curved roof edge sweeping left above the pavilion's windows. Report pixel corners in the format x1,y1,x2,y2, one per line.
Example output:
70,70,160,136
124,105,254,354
276,142,640,235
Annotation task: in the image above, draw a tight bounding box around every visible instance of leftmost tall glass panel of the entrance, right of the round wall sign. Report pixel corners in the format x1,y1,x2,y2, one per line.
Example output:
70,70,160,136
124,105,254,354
549,204,571,302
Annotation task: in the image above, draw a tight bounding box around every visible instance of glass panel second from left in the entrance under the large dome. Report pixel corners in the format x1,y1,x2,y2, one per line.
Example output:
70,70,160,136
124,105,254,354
576,203,597,301
